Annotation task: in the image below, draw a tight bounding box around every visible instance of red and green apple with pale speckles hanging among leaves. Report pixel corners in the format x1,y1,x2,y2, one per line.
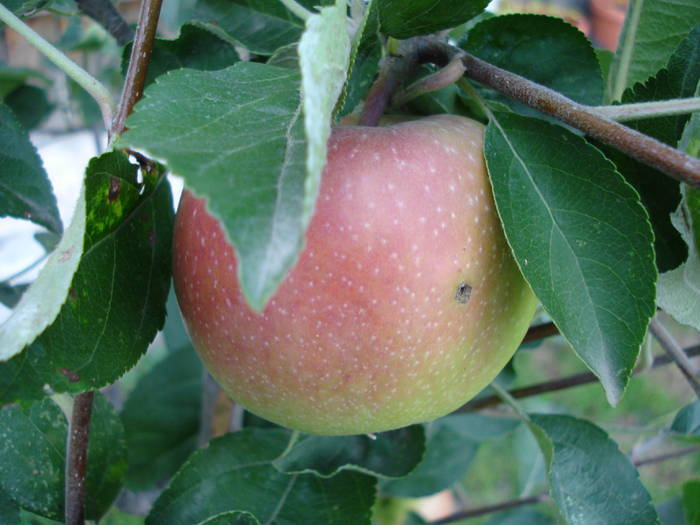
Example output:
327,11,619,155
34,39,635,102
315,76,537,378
173,115,536,435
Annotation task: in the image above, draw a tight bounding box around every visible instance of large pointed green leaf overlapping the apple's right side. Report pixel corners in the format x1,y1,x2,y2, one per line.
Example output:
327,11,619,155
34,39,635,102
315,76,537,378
485,113,656,404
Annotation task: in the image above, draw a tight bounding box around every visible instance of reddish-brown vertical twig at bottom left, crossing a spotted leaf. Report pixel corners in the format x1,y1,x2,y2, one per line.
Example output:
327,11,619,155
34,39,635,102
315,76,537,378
65,392,95,525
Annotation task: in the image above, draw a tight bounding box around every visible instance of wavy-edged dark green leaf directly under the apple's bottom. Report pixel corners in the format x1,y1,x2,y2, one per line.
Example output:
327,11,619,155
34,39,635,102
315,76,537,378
275,425,425,477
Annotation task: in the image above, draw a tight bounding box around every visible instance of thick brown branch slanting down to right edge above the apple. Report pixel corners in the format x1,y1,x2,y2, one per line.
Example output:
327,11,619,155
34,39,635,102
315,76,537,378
404,37,700,187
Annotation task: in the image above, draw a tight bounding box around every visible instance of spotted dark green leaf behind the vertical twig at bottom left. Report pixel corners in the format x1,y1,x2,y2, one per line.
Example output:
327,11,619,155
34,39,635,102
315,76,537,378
0,393,126,520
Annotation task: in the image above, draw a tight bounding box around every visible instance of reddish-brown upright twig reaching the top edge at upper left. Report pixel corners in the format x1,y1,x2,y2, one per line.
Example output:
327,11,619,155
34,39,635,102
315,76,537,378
111,0,162,137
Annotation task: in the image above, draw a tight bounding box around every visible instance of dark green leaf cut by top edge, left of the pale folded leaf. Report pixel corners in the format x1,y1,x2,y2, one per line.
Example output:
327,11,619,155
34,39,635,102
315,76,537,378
195,0,304,55
